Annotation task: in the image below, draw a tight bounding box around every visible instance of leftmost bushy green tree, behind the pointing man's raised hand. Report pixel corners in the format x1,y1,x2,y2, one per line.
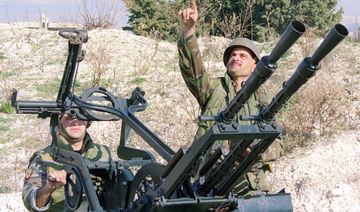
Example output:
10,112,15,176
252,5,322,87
123,0,221,40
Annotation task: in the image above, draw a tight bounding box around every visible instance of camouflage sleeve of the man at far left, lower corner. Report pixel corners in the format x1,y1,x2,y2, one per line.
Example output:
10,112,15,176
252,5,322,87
22,156,52,211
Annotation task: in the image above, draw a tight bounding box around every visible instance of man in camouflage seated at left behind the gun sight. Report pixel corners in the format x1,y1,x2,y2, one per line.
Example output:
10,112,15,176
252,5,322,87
22,114,111,211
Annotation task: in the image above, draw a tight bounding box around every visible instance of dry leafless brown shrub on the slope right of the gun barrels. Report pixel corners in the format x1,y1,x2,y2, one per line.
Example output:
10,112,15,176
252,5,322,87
279,74,346,150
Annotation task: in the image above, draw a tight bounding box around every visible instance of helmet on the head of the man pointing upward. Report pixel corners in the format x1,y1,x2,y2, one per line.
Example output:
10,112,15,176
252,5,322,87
223,38,260,66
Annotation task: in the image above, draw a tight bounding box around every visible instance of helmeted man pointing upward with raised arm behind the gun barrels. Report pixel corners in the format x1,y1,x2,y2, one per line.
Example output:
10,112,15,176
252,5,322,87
178,0,283,195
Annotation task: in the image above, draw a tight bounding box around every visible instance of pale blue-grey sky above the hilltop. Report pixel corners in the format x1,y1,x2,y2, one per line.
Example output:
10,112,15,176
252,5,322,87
0,0,360,32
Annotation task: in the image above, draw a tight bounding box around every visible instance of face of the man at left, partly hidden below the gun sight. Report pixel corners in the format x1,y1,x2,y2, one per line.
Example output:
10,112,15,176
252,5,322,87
60,114,86,140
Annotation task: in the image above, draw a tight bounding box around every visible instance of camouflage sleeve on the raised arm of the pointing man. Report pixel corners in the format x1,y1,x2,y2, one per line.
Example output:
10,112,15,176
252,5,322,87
178,34,210,108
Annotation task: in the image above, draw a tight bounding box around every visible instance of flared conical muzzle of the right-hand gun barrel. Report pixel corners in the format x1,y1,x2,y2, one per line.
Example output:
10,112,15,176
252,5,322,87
311,24,349,66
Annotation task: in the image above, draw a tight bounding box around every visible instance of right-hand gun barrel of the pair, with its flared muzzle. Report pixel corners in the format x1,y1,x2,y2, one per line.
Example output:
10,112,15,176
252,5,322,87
260,24,347,121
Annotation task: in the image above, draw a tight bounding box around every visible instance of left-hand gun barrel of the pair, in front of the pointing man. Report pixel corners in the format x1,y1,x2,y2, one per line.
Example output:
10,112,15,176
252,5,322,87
222,21,305,122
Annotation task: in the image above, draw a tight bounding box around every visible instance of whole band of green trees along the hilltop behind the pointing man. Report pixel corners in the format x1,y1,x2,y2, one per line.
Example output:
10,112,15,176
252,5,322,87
124,0,343,41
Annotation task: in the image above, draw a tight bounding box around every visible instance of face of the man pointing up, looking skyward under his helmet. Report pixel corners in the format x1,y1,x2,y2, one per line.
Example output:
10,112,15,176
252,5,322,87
226,47,256,77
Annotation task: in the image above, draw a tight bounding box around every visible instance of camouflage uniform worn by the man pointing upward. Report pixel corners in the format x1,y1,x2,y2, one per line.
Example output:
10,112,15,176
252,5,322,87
178,35,283,194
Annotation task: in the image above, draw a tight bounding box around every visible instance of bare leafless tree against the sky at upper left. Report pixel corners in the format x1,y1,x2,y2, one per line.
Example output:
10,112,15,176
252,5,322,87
76,0,126,29
